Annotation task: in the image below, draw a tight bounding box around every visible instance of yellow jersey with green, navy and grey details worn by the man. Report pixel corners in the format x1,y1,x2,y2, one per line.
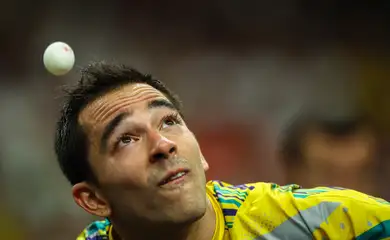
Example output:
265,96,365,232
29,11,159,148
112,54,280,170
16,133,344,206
77,181,390,240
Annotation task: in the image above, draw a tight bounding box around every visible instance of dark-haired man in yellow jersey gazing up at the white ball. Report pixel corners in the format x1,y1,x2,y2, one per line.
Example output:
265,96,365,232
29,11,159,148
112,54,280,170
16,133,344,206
55,62,390,240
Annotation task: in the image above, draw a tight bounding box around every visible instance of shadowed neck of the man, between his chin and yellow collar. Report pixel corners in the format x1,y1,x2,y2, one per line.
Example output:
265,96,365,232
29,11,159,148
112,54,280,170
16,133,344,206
112,198,216,240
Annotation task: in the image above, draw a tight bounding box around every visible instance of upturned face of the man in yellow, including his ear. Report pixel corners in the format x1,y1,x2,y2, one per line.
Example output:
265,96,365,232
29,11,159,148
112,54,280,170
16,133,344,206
73,84,207,223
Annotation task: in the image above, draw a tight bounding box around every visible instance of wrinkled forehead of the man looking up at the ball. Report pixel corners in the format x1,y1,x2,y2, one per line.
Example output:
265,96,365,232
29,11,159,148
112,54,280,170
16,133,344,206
79,83,167,129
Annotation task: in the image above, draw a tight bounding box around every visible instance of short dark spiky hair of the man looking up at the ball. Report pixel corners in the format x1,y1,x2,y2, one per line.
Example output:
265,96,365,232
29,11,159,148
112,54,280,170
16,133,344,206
55,61,182,185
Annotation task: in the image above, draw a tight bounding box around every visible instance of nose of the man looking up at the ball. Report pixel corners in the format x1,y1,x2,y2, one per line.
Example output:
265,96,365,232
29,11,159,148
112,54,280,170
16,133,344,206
150,133,177,163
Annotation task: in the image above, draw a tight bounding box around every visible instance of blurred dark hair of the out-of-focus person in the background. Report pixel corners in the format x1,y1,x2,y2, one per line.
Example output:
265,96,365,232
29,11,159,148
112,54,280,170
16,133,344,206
278,112,371,166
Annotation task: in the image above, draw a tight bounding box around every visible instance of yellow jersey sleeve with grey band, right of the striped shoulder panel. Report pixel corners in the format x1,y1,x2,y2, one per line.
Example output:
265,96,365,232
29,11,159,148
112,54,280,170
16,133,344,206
231,183,390,240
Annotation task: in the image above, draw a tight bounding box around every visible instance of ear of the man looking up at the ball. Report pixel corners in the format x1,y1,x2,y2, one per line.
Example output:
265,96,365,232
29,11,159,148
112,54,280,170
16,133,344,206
72,182,111,218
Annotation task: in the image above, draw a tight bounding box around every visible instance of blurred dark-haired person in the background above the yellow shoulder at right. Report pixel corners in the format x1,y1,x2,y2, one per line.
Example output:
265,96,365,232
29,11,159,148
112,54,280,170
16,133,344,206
280,113,379,195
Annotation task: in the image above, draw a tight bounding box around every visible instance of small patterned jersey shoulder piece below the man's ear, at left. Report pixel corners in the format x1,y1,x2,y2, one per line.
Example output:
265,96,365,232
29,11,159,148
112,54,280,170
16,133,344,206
76,219,111,240
